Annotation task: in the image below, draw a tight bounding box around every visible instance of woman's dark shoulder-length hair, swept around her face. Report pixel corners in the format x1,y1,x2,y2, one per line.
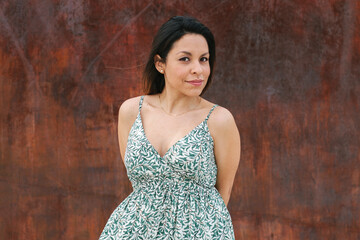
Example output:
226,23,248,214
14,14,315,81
143,16,216,95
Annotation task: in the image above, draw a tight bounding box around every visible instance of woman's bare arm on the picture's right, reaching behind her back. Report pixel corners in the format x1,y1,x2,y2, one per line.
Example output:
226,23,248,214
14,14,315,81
209,107,241,206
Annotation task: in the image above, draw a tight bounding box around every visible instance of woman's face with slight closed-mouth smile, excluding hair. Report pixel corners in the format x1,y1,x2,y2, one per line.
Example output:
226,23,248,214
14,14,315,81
158,33,210,96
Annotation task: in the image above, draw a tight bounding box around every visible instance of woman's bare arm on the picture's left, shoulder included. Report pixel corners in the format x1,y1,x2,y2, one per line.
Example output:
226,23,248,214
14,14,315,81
118,97,140,162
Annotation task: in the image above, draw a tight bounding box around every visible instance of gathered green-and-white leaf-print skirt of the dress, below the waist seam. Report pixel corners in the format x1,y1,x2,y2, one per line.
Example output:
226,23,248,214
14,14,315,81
100,180,235,240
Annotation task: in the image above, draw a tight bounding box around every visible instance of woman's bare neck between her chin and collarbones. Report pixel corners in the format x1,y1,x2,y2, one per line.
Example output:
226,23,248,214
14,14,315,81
159,88,201,117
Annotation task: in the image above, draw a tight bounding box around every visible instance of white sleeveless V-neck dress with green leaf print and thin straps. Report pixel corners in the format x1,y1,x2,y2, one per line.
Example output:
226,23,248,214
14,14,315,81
100,96,235,240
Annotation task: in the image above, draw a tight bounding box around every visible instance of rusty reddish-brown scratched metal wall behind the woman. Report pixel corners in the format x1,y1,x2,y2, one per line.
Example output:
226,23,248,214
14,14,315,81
0,0,360,240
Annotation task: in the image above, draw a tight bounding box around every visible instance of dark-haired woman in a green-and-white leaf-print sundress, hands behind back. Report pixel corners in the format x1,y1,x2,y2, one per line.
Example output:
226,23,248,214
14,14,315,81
100,17,240,239
